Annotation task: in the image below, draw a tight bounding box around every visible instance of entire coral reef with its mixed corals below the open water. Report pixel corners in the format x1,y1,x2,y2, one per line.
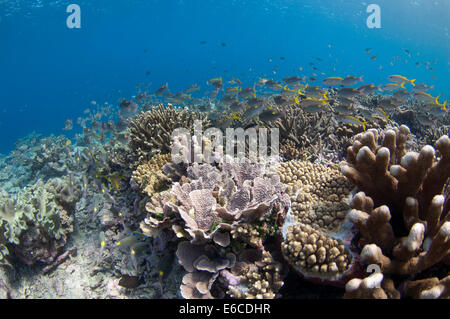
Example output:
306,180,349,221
0,58,450,299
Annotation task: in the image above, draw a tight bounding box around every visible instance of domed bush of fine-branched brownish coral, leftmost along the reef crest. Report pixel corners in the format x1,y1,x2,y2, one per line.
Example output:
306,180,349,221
129,104,209,166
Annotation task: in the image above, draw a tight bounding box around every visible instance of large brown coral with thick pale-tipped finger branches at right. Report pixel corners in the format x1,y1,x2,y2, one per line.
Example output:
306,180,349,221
340,126,450,296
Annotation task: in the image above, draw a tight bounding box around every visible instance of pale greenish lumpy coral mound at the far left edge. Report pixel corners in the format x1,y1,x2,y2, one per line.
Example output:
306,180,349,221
0,179,80,265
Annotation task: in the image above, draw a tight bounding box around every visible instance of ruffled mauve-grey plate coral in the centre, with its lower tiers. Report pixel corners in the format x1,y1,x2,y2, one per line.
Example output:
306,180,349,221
141,158,289,298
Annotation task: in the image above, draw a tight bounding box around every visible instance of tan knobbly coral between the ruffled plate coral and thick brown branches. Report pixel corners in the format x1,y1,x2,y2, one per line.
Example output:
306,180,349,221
278,161,353,282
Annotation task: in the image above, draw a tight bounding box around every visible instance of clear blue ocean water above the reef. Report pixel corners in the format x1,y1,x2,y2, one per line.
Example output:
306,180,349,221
0,0,450,153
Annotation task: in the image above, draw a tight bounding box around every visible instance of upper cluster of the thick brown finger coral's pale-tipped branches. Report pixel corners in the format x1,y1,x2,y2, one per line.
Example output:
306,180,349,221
341,125,450,212
